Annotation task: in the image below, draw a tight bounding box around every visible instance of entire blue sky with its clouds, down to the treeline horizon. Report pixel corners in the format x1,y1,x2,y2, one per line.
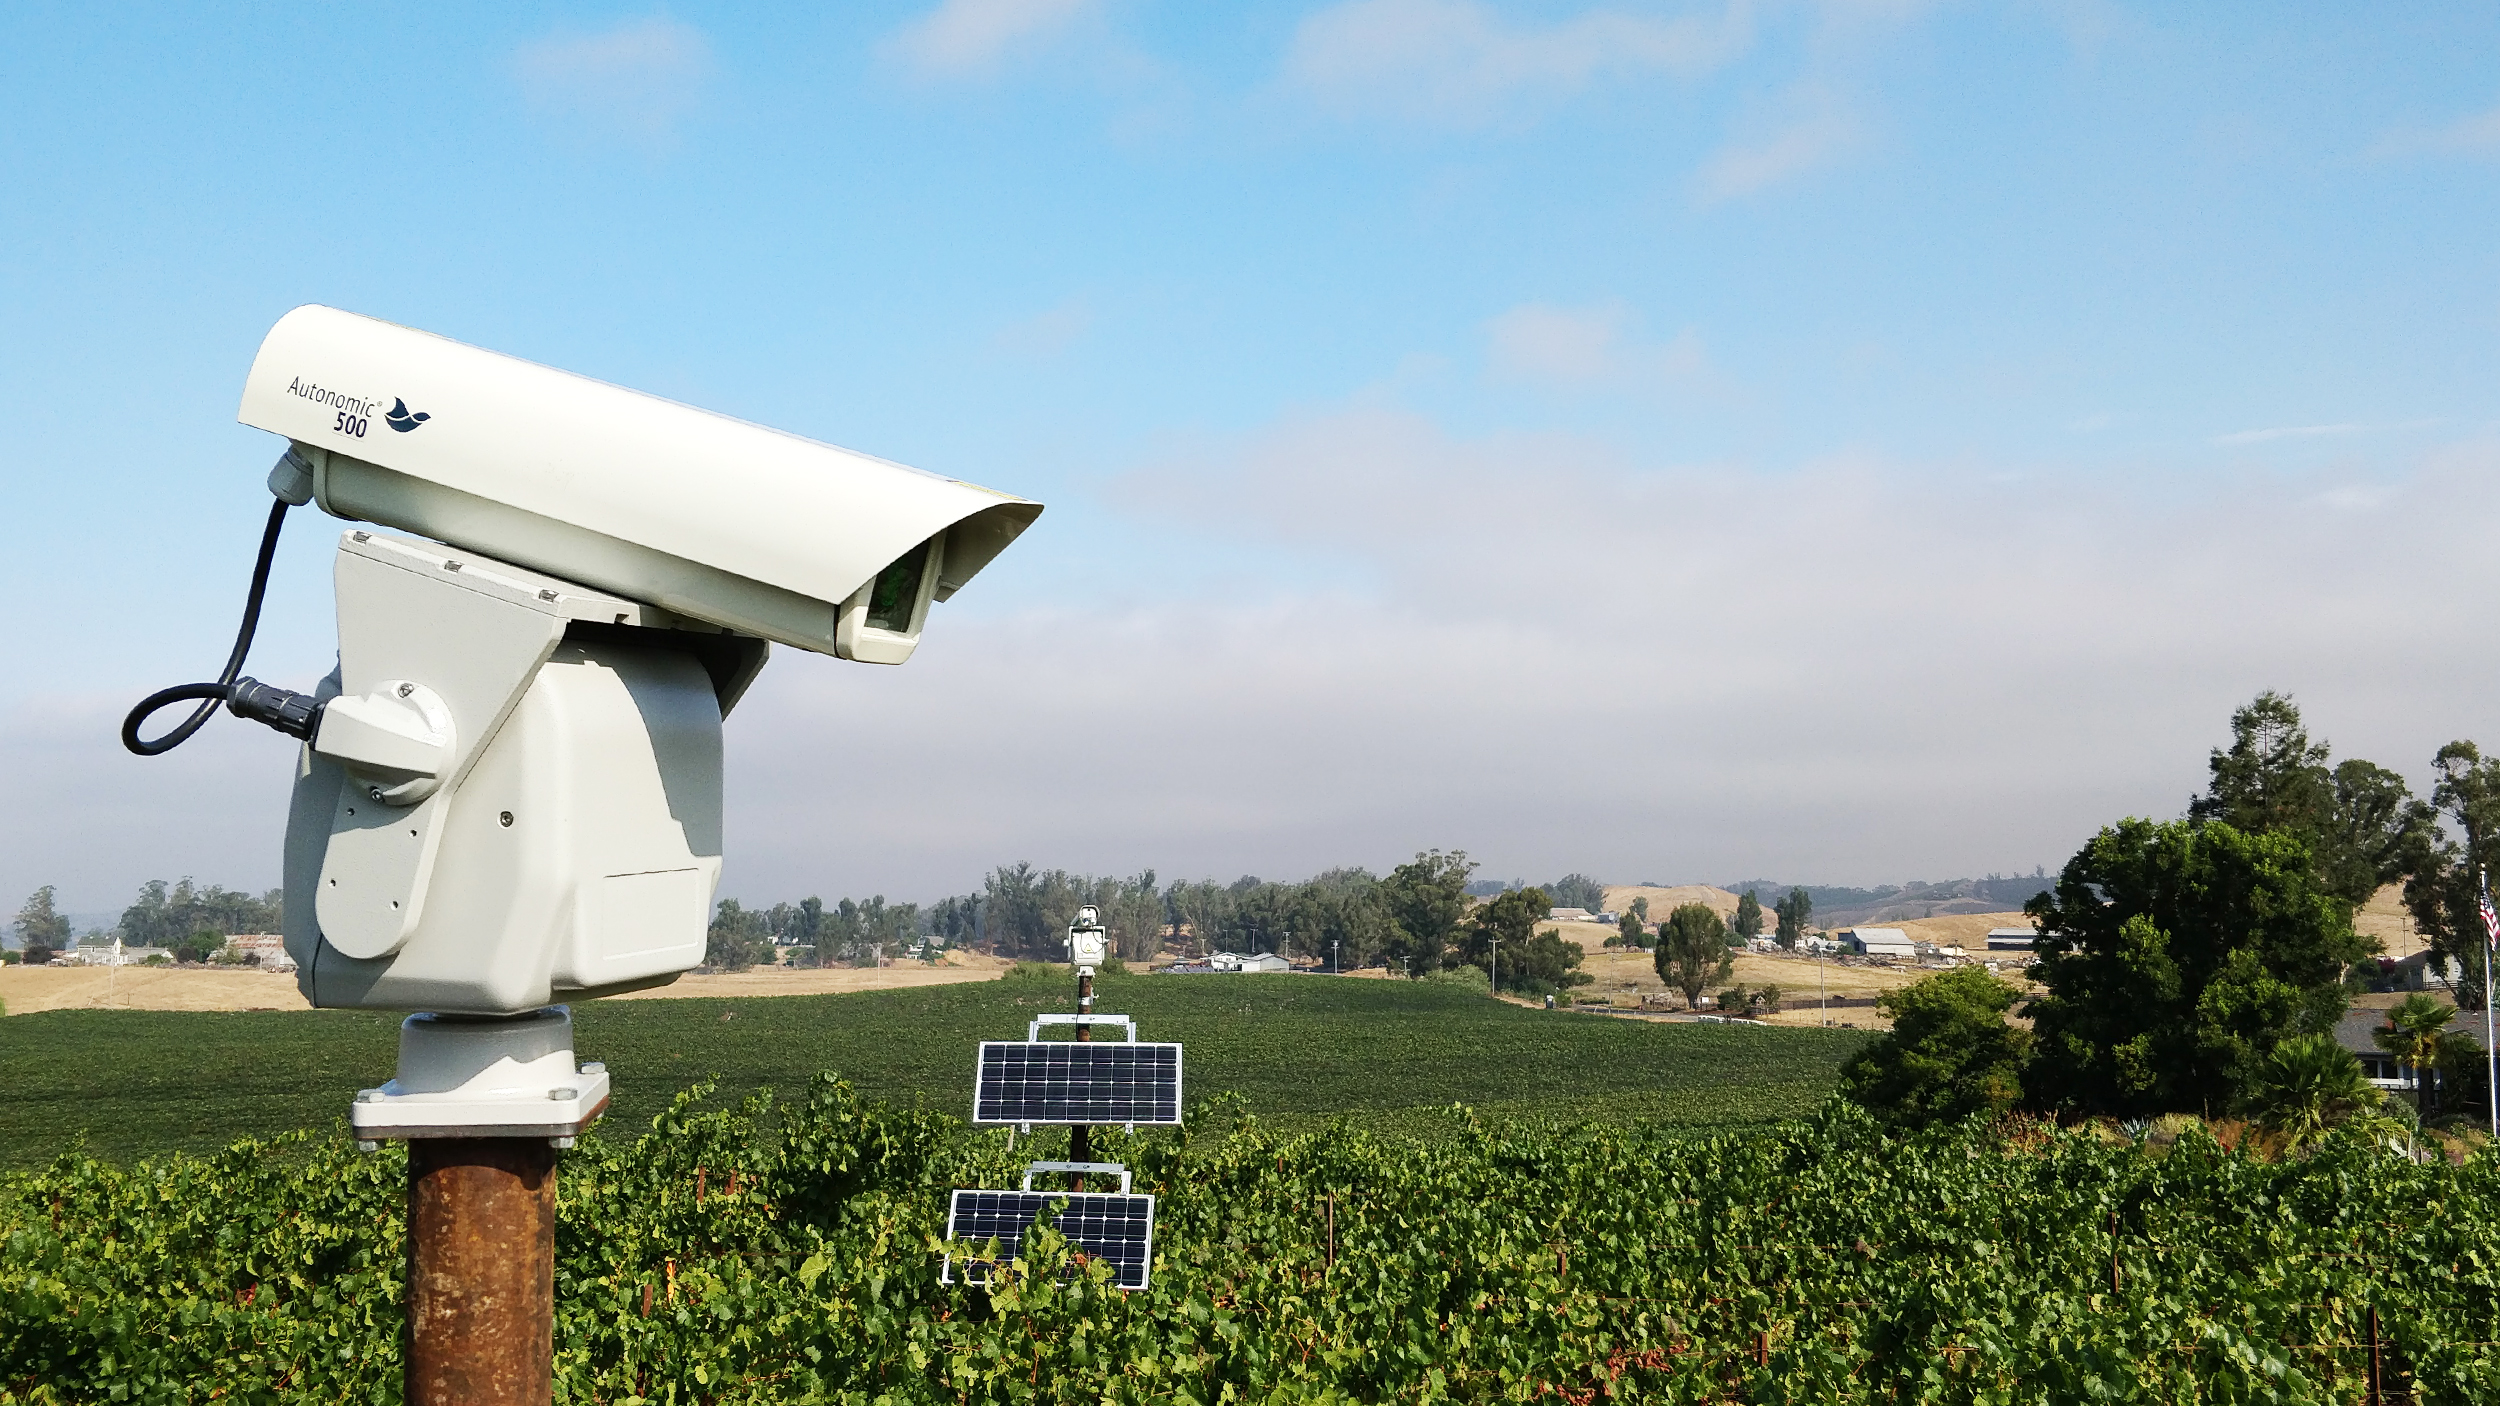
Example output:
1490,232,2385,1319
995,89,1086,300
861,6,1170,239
0,0,2500,911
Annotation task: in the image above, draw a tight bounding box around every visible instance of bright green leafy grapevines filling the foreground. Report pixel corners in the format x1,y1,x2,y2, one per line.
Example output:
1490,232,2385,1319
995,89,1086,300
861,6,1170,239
0,1078,2500,1406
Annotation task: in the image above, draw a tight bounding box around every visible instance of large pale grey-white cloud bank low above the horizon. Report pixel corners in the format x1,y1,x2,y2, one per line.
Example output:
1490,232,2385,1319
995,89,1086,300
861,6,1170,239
19,410,2500,911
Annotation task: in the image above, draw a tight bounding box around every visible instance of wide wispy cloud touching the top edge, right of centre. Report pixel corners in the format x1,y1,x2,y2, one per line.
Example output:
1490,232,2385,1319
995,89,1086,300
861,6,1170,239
1285,0,1753,125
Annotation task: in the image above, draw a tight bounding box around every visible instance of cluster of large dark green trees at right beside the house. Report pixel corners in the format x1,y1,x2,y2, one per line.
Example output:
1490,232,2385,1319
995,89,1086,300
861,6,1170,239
1843,693,2500,1128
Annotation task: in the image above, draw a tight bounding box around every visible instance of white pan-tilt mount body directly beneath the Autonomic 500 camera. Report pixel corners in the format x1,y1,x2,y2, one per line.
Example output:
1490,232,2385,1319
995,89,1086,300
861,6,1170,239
285,533,768,1013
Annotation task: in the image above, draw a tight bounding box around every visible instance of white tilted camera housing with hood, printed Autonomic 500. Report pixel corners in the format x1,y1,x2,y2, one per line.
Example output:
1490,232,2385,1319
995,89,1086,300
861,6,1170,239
238,305,1043,663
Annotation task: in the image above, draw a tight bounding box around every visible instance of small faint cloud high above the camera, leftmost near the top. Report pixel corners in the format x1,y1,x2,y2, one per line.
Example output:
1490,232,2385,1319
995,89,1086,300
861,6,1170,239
513,15,713,143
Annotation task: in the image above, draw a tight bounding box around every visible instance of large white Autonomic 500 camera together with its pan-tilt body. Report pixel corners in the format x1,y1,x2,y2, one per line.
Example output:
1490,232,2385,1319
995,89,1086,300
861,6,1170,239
240,308,1040,1010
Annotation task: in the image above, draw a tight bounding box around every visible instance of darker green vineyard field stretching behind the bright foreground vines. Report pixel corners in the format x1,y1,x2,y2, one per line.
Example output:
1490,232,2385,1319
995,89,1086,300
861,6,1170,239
0,973,1865,1166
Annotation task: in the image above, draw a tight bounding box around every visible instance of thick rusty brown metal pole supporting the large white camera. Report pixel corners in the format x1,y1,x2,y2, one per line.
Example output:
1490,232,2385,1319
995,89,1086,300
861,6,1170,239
405,1138,555,1406
